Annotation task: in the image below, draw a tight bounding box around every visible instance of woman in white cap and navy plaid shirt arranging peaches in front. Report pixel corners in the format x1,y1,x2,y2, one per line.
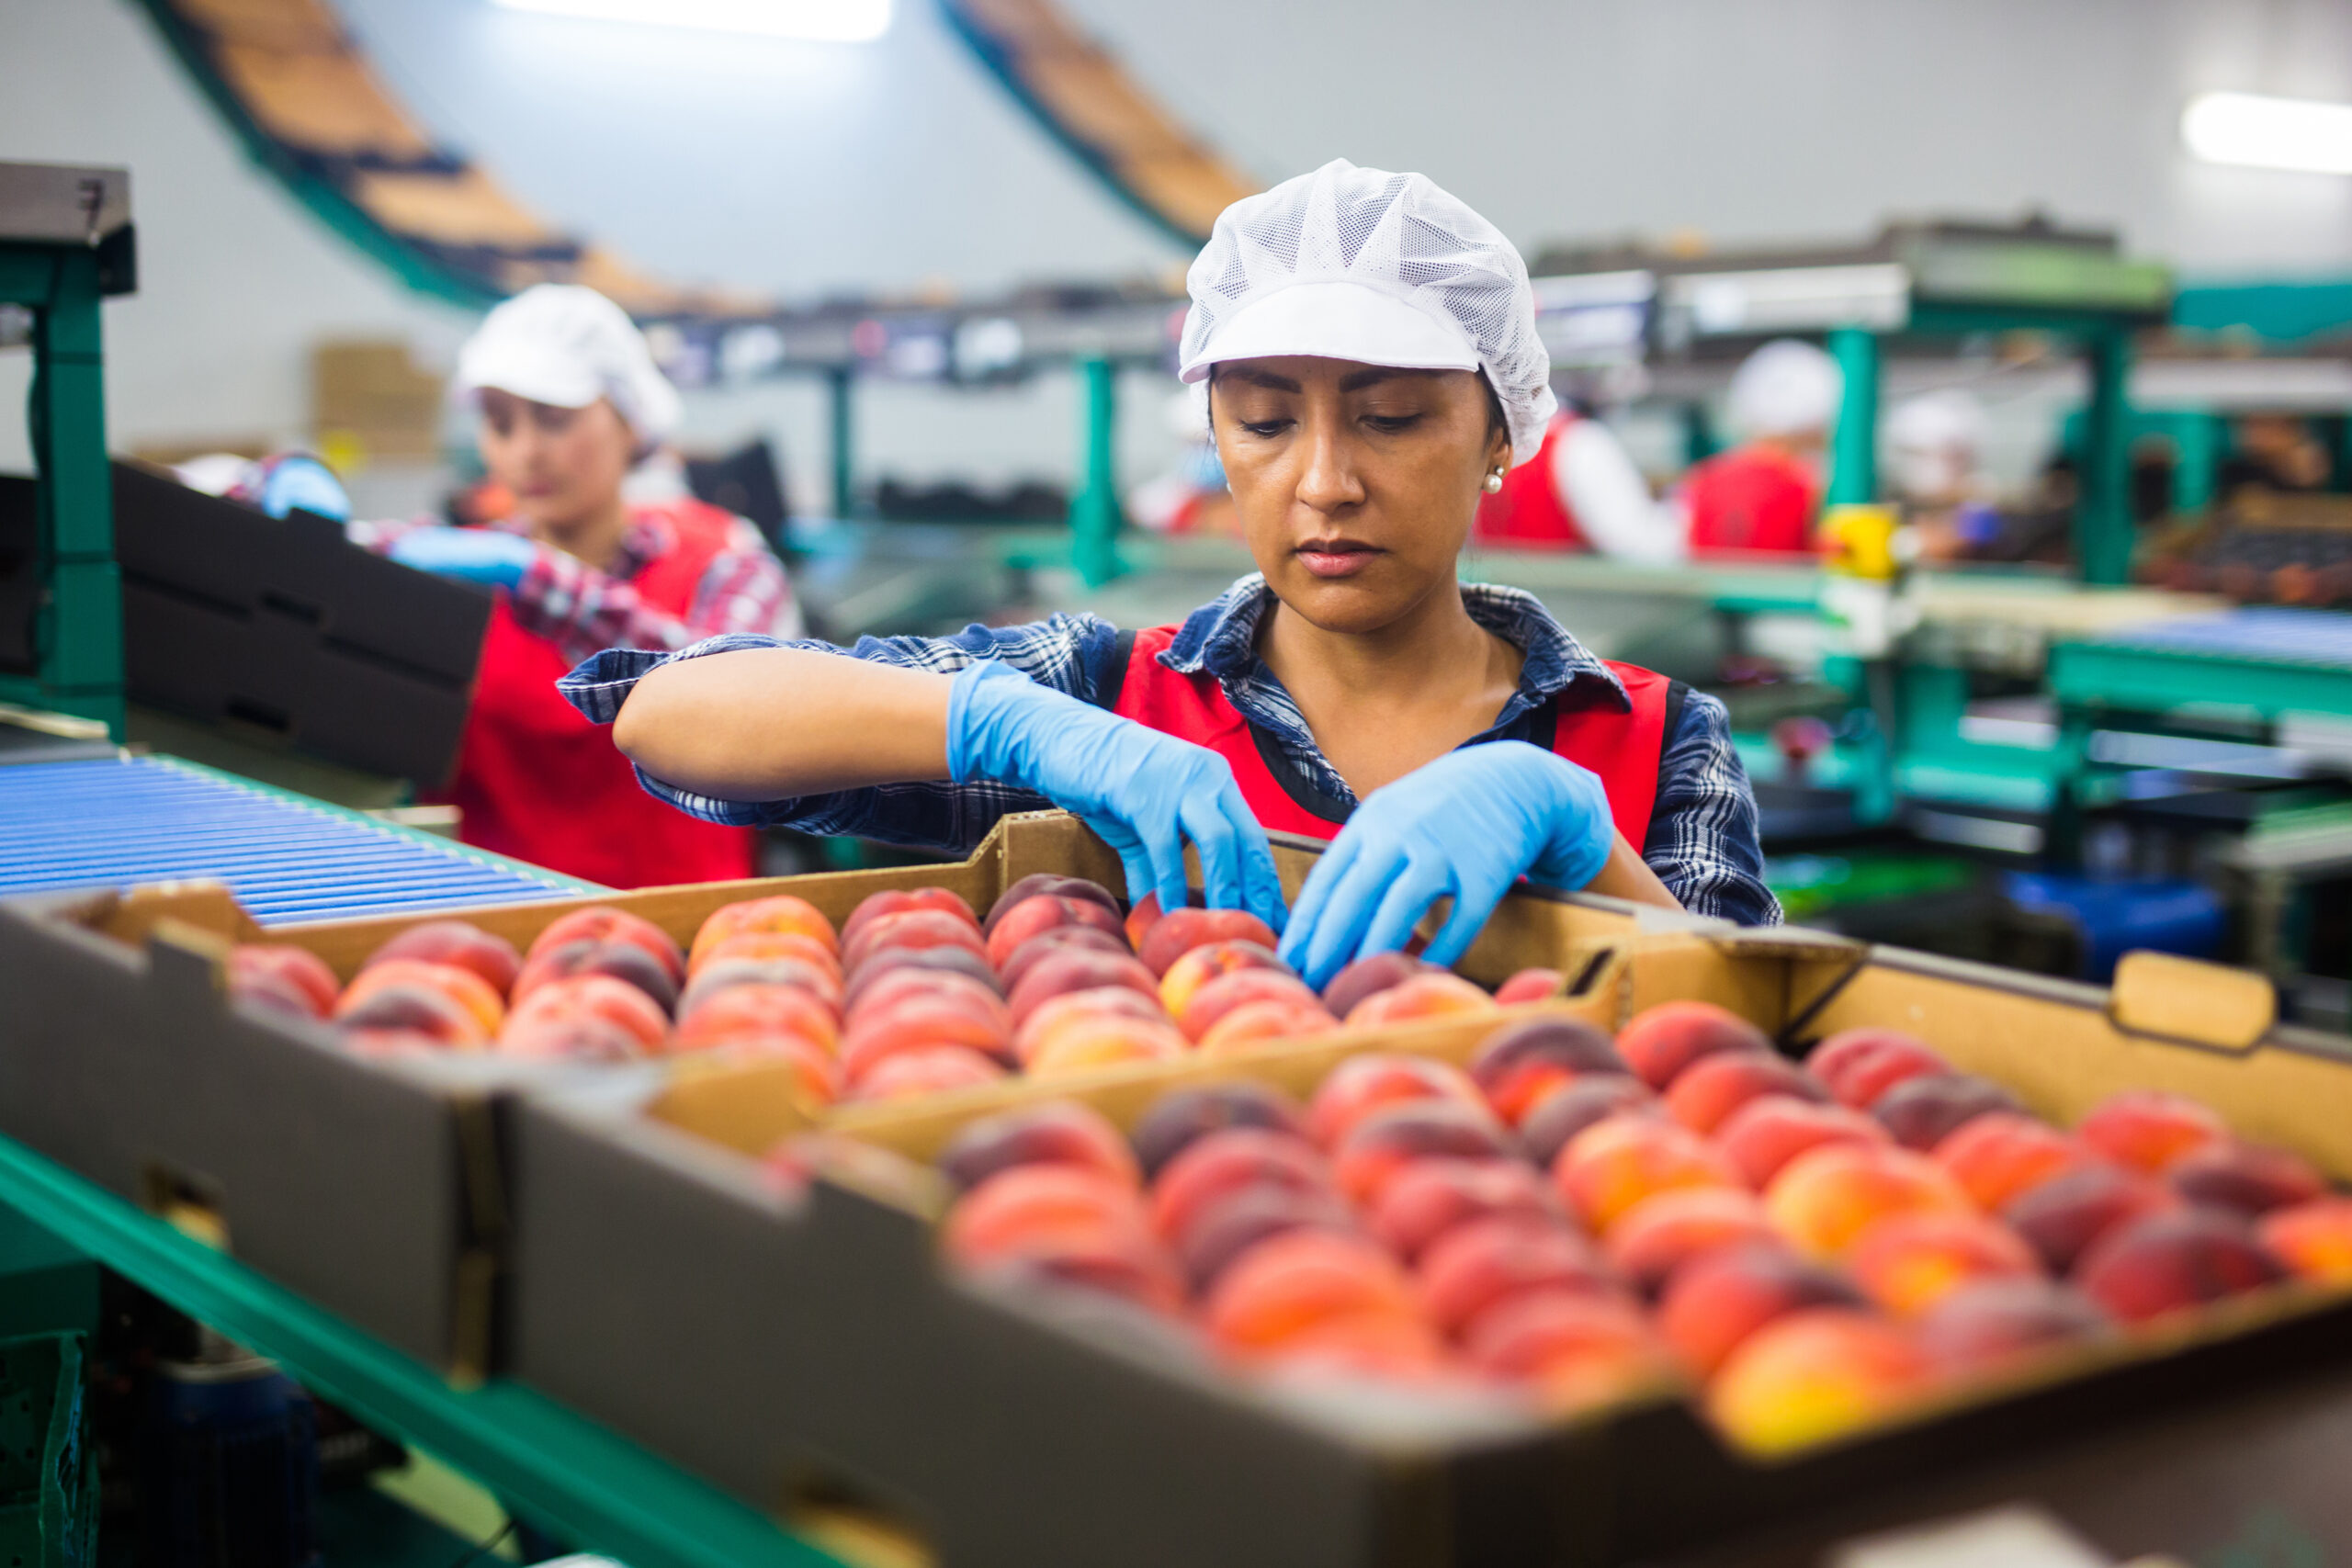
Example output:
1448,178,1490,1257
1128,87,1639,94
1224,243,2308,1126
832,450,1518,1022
562,160,1778,987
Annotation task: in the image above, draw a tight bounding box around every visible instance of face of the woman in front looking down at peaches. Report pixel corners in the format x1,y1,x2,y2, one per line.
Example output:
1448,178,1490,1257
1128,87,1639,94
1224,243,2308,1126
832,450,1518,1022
1209,355,1510,632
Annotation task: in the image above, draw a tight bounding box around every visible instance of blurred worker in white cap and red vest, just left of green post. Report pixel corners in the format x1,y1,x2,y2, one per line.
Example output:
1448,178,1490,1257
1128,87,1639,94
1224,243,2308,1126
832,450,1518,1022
1681,339,1844,555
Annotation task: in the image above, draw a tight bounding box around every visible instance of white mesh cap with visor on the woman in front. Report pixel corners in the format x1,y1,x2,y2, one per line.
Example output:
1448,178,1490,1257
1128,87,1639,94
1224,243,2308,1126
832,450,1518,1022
1176,157,1557,466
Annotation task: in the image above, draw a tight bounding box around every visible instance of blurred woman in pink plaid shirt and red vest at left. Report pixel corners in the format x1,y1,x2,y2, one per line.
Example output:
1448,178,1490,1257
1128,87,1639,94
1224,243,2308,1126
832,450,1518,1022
356,285,802,886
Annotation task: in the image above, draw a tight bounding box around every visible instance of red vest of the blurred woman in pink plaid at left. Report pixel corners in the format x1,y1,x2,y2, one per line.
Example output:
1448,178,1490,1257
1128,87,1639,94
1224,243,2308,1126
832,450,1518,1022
423,501,752,888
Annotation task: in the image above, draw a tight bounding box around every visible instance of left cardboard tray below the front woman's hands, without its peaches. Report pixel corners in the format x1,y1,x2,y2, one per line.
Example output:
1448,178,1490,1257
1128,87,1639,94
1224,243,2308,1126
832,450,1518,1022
0,813,1693,1375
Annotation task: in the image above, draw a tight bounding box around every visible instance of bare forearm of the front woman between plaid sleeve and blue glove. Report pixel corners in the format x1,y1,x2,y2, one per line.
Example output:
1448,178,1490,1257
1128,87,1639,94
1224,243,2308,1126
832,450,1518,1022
612,649,953,799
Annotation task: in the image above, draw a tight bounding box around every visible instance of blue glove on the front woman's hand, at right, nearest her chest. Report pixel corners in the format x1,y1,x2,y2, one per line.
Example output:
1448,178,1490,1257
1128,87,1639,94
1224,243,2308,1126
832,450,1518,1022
1282,740,1616,989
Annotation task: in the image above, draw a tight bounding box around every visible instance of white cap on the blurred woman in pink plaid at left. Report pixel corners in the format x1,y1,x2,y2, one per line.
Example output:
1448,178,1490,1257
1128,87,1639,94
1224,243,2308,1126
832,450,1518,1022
449,282,684,446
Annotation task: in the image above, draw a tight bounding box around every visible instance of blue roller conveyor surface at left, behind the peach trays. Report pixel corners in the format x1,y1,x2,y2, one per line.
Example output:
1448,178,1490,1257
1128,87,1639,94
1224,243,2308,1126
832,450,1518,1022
0,757,585,924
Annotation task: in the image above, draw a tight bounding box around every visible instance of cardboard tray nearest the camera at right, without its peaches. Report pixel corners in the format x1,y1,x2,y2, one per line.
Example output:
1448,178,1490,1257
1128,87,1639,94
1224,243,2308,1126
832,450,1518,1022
513,926,2352,1568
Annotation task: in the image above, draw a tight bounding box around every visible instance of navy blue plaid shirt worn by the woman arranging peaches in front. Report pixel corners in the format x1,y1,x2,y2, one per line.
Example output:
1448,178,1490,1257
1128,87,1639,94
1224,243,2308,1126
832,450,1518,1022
560,573,1781,926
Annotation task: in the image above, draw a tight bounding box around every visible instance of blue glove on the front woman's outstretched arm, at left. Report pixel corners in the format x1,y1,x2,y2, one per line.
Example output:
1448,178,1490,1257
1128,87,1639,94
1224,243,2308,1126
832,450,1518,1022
948,659,1282,931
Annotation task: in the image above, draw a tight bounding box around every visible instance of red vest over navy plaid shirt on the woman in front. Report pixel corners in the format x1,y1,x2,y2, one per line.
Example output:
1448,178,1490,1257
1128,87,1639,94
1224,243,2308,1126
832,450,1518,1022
1113,626,1681,851
